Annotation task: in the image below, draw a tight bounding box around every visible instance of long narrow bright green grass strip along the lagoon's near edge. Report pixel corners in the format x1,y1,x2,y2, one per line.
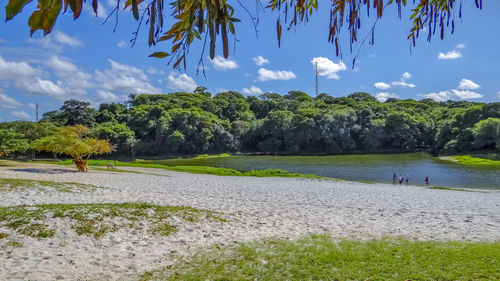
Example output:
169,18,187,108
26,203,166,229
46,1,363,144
32,159,331,180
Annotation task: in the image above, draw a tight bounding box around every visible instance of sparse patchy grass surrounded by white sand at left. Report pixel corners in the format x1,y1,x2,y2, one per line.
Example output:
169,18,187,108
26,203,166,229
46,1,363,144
0,203,224,239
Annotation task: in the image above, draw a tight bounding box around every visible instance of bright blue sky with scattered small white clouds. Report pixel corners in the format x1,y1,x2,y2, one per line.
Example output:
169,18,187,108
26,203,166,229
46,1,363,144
0,0,500,122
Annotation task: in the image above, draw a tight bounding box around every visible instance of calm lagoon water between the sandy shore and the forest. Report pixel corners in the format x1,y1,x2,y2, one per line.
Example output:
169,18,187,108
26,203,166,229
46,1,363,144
148,153,500,190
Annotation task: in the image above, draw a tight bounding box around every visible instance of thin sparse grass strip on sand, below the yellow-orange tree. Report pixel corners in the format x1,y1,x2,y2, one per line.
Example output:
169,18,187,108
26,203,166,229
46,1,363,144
0,178,99,192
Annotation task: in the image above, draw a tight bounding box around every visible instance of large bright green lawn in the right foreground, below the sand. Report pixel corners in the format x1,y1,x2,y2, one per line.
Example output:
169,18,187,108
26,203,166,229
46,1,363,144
140,236,500,281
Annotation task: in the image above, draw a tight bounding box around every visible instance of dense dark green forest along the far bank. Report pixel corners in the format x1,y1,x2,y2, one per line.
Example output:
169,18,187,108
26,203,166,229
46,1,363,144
0,87,500,157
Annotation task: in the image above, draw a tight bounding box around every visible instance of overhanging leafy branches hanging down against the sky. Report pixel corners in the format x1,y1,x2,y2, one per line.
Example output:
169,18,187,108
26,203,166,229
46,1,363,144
5,0,482,68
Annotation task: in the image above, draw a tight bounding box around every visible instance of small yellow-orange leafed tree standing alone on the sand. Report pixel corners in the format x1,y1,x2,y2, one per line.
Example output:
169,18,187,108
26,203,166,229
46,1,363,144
31,125,113,172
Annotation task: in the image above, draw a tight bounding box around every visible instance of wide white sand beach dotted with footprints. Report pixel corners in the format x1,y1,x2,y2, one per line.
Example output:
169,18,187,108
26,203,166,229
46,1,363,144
0,164,500,280
